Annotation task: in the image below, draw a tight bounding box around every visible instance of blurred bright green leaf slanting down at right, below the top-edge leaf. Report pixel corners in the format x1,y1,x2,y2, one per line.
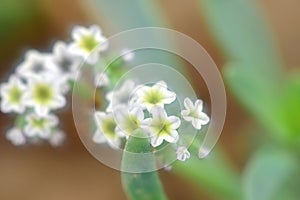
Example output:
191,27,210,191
224,63,287,141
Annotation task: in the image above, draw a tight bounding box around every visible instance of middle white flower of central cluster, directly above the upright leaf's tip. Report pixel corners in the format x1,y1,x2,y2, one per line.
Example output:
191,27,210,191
114,107,144,136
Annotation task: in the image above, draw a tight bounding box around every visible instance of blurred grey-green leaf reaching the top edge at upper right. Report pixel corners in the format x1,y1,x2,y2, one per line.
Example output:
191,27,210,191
200,0,282,71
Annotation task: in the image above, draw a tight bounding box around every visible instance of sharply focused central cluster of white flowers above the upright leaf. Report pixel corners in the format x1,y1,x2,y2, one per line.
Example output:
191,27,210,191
93,80,209,161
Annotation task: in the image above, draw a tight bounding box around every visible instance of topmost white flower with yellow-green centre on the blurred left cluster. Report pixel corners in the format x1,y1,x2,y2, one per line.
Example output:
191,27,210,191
70,25,108,64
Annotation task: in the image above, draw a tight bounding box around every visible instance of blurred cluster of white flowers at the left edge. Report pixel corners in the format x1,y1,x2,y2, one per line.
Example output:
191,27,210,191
0,25,107,146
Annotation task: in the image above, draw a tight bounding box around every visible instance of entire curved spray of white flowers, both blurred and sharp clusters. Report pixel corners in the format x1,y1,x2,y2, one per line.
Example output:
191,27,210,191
0,25,209,164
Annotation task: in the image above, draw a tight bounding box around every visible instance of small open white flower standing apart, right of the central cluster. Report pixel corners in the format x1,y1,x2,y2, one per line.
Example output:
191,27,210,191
181,98,209,130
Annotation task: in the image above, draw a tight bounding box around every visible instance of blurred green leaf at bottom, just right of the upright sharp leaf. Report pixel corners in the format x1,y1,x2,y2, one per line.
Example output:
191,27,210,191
173,146,242,200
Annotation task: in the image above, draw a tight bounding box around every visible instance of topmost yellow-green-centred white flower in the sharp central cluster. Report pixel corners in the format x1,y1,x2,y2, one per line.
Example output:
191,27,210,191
135,81,176,111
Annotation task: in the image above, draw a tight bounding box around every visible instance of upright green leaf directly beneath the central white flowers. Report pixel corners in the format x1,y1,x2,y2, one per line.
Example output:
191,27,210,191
122,132,167,200
